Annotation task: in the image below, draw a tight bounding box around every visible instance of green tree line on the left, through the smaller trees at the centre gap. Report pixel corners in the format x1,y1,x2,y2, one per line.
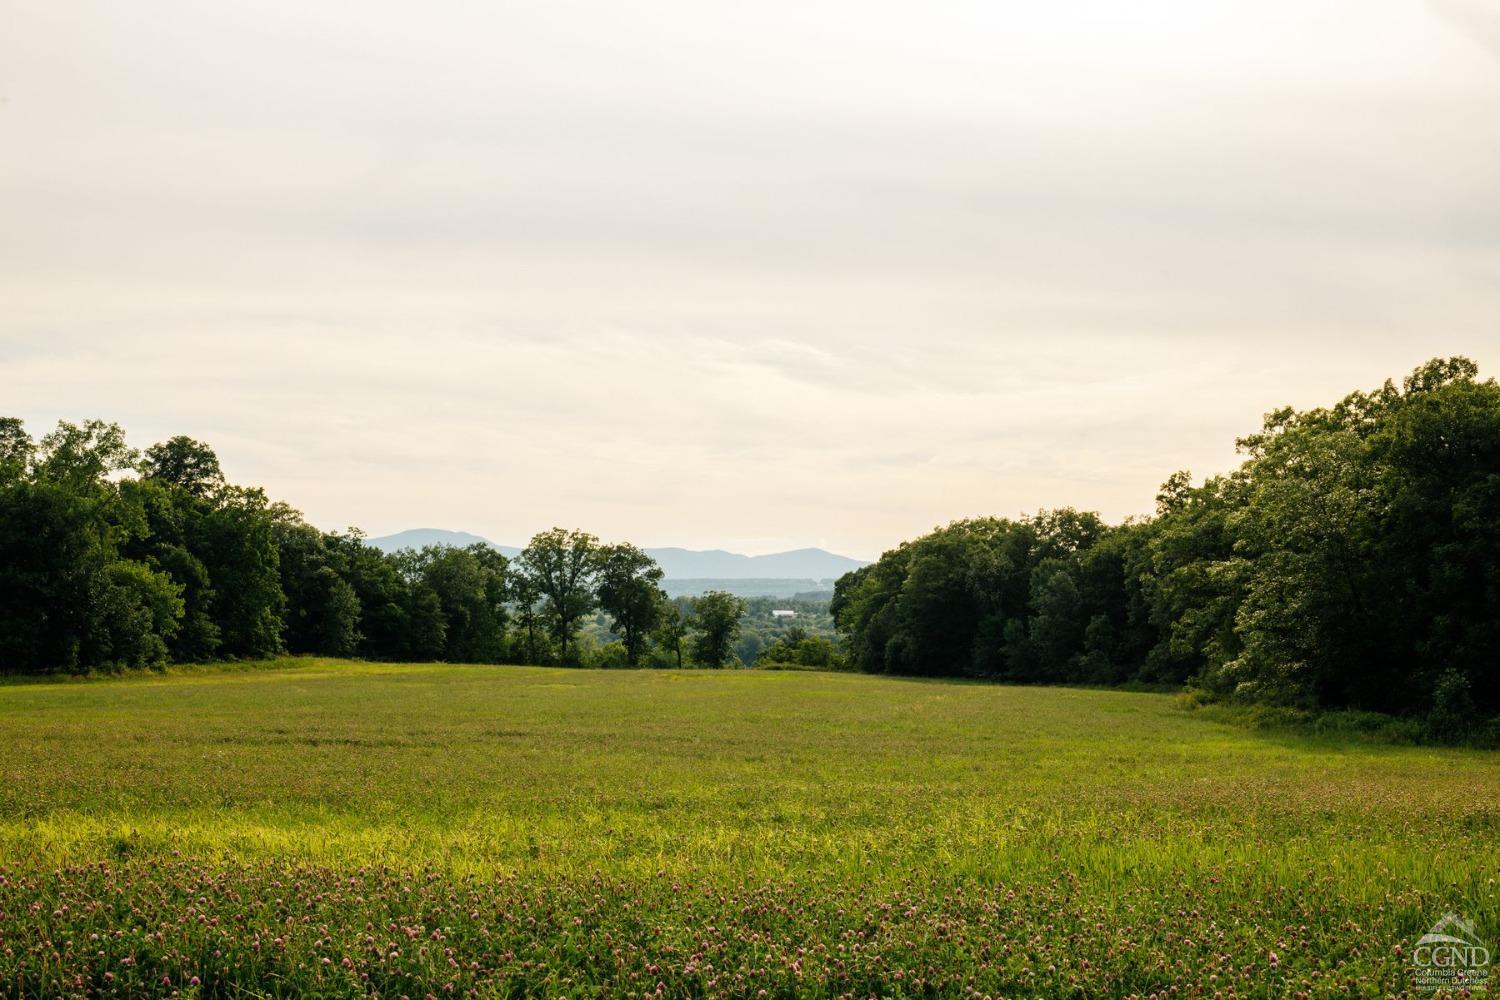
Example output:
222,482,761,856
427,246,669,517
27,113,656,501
0,418,746,673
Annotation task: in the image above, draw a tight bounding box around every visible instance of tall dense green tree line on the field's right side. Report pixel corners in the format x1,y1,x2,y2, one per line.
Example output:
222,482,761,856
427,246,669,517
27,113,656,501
833,358,1500,730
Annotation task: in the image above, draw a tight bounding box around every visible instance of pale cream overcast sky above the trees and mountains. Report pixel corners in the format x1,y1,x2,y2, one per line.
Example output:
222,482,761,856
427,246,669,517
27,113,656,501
0,0,1500,558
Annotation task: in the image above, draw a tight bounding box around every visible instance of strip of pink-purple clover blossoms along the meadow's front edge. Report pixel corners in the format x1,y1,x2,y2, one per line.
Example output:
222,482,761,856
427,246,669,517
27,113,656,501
0,858,1476,1000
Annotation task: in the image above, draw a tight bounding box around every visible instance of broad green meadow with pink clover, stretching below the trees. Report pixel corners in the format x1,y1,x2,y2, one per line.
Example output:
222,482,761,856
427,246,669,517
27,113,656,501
0,660,1500,997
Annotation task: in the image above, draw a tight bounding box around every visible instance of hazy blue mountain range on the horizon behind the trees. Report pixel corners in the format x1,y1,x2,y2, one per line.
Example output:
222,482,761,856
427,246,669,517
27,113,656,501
366,528,867,589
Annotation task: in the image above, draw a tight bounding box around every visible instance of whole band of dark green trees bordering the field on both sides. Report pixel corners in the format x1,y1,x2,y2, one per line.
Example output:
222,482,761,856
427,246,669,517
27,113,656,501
0,358,1500,732
